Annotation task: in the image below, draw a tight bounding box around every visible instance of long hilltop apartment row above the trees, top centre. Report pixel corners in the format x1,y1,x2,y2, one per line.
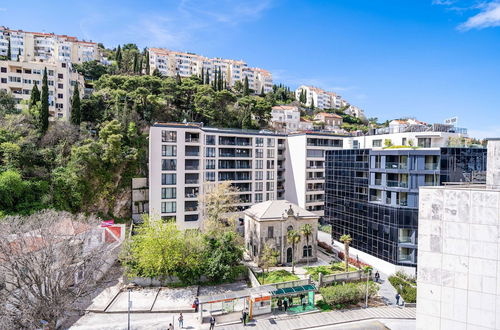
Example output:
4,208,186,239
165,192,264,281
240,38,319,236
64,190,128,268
149,48,273,93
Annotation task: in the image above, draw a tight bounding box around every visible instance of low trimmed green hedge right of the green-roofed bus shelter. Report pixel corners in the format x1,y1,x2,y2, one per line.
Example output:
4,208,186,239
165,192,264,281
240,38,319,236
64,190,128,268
319,282,378,307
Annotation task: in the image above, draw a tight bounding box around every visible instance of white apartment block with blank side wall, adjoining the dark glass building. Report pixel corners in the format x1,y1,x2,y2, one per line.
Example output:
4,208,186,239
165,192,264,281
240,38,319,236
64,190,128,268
284,132,346,217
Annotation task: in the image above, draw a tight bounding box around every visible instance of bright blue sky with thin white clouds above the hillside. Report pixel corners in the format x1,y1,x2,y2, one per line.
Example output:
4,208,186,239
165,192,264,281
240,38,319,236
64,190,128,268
0,0,500,137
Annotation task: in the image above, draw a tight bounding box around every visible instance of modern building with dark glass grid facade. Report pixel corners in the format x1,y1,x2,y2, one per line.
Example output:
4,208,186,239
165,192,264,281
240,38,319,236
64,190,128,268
325,129,486,273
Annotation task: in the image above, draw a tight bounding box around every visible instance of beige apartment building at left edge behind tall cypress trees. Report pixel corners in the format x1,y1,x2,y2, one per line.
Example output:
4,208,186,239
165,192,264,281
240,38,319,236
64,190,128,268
0,58,84,120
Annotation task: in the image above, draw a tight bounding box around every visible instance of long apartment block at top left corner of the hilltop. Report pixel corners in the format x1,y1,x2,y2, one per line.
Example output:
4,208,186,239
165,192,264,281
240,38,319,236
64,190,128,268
0,26,100,63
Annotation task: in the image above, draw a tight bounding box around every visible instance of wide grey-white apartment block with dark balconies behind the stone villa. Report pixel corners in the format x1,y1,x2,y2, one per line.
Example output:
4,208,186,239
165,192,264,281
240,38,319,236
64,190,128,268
149,123,286,229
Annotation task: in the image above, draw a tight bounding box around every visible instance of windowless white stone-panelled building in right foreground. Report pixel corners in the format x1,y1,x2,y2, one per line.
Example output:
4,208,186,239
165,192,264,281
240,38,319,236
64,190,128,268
417,139,500,330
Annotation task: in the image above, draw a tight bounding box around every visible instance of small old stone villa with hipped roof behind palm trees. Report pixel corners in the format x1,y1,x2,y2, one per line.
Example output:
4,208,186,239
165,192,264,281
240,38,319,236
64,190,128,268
244,200,318,264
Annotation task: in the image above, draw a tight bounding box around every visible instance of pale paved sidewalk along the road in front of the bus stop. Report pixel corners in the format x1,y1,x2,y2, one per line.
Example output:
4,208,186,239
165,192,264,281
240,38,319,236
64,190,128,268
217,306,416,330
